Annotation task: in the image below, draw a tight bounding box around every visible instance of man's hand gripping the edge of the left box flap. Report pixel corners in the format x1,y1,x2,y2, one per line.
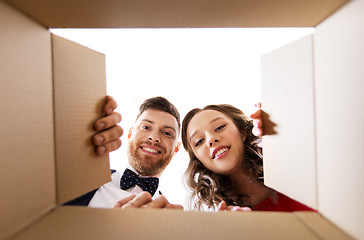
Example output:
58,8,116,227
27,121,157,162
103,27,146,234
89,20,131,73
92,96,124,155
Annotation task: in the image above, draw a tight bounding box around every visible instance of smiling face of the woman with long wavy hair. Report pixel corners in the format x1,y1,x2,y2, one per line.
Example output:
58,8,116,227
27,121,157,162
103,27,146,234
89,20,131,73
187,110,244,175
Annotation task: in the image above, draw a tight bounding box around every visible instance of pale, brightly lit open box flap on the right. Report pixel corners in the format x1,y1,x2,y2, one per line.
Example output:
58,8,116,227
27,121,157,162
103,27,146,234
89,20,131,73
261,35,318,209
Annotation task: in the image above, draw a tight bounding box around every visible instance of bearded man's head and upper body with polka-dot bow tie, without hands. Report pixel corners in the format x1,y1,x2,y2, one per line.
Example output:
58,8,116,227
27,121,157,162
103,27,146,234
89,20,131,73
66,97,180,208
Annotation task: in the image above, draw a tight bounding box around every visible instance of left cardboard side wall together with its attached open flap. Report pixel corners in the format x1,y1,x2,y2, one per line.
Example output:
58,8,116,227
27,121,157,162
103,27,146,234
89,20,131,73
0,2,110,238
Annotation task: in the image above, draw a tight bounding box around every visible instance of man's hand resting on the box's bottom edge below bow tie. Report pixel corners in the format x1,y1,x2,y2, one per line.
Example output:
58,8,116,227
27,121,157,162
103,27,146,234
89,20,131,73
113,192,183,210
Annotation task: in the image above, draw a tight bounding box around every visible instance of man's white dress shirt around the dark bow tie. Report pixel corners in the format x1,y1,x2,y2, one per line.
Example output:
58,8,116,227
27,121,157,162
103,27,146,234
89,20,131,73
88,166,160,208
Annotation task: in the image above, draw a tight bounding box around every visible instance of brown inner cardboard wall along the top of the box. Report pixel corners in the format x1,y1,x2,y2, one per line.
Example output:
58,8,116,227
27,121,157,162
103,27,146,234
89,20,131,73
6,0,347,28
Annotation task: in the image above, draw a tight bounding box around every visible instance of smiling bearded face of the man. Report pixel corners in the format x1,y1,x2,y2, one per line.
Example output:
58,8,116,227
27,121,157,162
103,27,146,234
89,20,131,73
128,109,179,176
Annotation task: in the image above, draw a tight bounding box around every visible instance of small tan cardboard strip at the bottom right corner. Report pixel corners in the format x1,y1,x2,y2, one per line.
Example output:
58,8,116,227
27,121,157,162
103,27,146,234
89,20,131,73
293,212,351,240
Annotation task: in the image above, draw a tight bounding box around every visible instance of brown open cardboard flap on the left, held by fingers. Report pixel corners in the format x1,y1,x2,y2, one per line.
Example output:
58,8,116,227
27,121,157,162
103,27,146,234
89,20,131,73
52,35,111,203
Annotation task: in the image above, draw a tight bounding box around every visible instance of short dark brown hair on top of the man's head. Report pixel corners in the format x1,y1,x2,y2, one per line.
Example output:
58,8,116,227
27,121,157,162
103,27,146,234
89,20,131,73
136,97,181,129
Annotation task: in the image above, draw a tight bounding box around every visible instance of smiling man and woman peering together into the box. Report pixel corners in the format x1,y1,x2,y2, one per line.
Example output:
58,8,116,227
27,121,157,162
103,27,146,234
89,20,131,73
69,97,315,212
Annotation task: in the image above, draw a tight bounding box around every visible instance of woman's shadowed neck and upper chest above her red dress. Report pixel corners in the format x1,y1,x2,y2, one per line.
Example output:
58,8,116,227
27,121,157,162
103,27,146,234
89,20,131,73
229,171,274,206
